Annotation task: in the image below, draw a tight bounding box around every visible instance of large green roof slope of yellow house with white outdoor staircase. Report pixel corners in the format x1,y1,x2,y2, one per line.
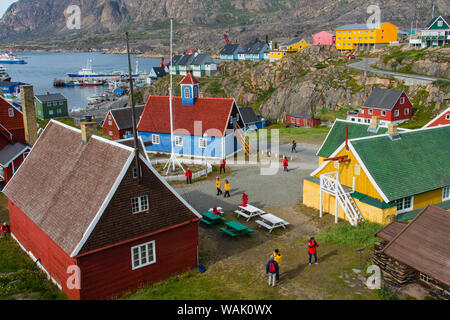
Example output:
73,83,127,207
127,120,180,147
349,126,450,202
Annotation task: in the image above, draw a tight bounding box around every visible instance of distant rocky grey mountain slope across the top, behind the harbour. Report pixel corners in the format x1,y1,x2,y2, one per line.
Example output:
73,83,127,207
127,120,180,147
0,0,448,53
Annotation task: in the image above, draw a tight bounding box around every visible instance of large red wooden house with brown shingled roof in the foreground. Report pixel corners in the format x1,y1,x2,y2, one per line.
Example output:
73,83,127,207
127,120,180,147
3,120,200,299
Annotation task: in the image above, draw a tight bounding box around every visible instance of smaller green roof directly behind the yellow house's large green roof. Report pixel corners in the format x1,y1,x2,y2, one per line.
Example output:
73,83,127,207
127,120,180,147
317,119,387,158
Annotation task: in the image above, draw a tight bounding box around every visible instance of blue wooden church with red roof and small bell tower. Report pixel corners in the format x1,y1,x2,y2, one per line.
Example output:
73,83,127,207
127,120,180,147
138,73,245,158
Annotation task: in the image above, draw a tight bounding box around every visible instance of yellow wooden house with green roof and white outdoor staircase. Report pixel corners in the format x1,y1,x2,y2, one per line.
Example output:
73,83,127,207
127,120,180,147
303,124,450,225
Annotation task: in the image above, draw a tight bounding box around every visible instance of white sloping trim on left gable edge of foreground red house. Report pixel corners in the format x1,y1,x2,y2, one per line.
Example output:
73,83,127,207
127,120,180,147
70,151,135,258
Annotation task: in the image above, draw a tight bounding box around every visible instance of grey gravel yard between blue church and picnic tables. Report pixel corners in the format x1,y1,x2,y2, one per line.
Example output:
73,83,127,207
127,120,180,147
176,143,319,212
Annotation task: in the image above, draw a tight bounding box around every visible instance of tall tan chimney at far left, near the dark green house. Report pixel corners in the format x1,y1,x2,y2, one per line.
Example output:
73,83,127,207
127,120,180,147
20,85,37,146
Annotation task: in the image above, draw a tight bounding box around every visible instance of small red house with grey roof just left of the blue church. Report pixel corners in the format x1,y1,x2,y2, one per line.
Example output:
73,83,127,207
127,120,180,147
102,106,144,140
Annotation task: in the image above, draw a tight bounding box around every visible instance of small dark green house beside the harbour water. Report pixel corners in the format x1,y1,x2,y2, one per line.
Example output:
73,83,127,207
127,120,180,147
34,92,69,120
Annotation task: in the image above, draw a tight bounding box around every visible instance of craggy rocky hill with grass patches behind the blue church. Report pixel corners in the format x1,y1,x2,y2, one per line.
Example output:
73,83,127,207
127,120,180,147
139,46,450,125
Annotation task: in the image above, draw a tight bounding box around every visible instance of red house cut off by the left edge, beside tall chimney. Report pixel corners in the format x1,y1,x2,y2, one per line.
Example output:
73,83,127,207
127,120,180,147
0,90,37,184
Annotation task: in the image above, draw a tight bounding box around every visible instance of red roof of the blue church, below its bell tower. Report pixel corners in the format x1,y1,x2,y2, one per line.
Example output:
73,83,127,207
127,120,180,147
138,96,234,137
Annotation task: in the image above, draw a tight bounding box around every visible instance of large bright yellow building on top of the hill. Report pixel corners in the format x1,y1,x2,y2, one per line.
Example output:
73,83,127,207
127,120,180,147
336,22,398,50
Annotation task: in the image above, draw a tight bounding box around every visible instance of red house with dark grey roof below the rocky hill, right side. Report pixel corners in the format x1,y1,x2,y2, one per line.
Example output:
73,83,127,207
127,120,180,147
347,87,413,125
